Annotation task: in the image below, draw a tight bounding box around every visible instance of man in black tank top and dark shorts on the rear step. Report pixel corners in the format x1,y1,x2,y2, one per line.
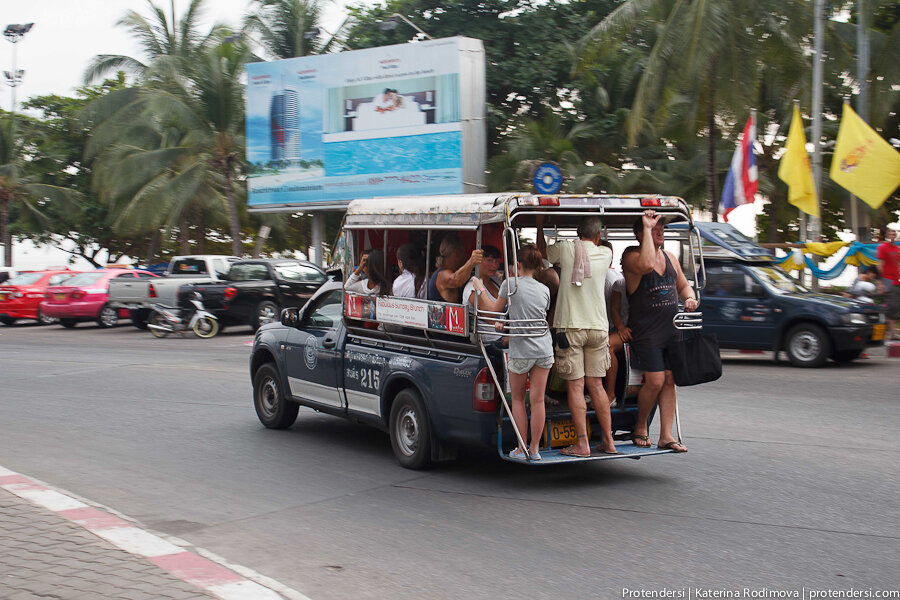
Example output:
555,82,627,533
622,210,698,452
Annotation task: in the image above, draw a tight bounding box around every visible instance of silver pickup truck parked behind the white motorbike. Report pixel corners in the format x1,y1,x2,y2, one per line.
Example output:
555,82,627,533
109,254,239,329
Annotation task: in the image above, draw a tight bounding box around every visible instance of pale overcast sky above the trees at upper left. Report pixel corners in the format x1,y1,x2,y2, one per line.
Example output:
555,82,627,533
0,0,343,110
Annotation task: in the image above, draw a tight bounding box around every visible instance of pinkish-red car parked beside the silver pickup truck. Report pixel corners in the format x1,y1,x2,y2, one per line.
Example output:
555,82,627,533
41,269,156,327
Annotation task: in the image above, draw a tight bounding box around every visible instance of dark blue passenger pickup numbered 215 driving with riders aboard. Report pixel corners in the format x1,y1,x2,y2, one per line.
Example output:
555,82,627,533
250,194,708,469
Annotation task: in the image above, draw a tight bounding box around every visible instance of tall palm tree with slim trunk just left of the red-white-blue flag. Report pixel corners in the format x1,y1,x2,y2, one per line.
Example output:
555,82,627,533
583,0,811,218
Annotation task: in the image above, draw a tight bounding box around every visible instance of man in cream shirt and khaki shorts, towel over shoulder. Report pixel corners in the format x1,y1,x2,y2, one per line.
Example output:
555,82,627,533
537,216,619,458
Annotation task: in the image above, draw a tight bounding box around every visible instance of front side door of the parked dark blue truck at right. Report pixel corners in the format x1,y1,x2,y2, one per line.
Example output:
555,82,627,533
700,264,775,349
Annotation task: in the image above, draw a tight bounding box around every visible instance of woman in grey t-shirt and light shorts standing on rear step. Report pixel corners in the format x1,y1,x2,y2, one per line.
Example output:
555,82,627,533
472,245,553,461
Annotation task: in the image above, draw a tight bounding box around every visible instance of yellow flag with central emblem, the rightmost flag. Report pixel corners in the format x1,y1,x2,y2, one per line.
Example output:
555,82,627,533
831,104,900,208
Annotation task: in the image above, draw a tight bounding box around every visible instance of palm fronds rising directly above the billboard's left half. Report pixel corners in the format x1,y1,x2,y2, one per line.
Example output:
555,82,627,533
244,0,333,58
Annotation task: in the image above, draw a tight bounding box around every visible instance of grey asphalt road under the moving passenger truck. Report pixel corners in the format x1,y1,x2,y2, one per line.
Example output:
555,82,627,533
0,324,900,600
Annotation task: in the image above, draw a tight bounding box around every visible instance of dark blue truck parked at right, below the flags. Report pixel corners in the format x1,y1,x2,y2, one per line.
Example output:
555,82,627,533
673,223,885,367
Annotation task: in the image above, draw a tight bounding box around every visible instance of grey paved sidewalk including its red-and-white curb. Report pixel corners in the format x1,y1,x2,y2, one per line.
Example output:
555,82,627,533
0,467,292,600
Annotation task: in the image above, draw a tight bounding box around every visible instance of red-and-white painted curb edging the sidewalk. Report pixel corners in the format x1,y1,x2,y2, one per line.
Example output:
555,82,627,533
0,466,309,600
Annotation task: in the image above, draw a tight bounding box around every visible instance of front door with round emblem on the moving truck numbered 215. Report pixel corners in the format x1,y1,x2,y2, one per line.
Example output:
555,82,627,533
284,289,343,407
